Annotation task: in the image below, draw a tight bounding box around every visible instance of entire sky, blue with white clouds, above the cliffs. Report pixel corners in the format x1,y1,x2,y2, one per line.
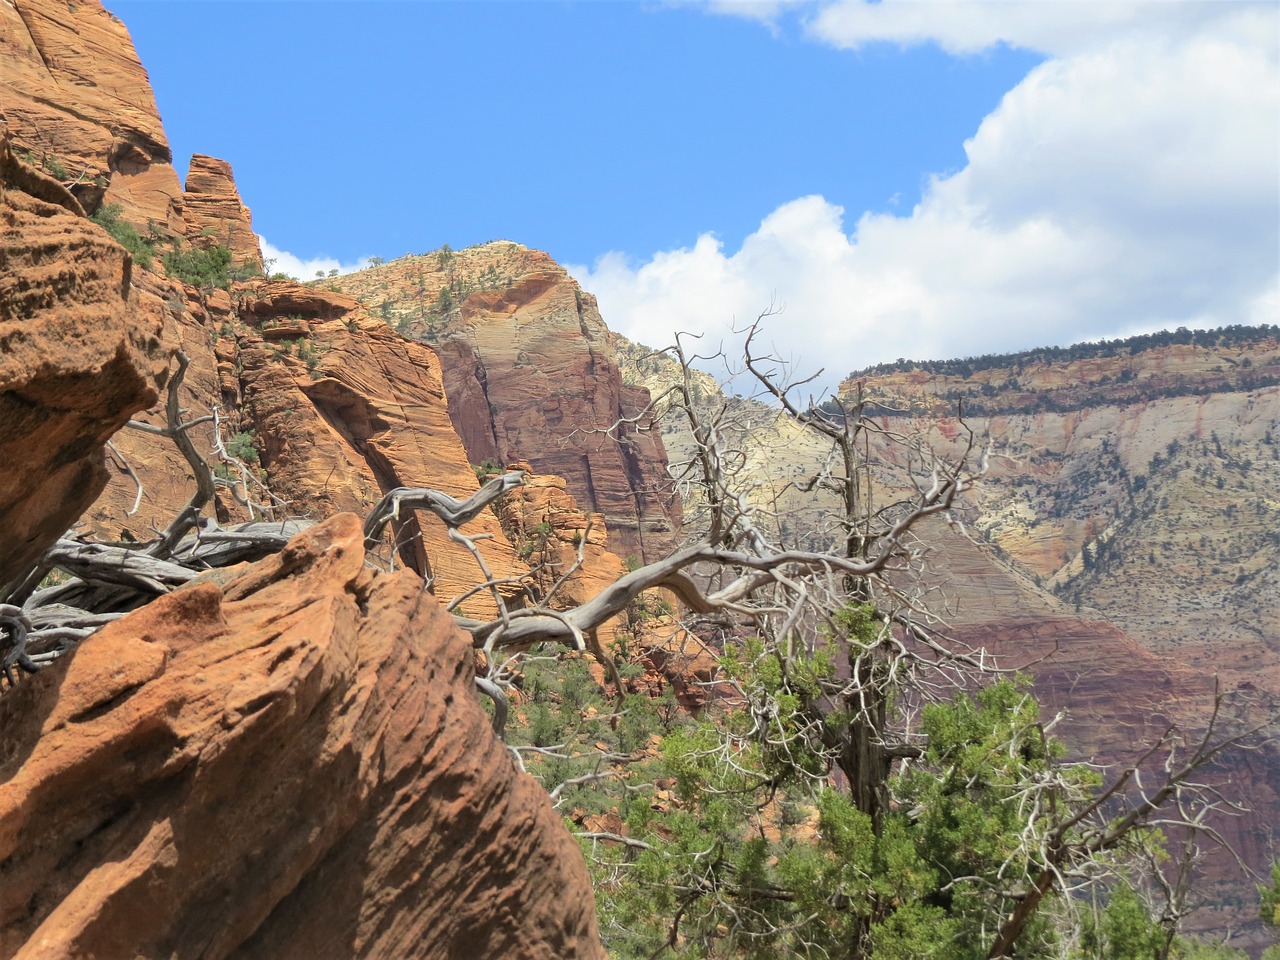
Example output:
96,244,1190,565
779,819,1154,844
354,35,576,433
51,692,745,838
106,0,1280,383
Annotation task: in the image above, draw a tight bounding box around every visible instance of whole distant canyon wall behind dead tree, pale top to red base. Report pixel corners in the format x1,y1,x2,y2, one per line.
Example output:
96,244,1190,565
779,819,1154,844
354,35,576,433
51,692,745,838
620,330,1280,931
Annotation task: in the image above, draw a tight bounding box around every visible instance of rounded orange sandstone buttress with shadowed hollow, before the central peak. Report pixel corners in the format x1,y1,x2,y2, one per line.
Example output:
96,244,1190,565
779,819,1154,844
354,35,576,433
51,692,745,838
232,282,527,613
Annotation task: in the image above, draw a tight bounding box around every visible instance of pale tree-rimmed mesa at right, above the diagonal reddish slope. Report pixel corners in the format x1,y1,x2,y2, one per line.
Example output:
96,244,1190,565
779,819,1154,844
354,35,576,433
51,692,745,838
839,330,1280,695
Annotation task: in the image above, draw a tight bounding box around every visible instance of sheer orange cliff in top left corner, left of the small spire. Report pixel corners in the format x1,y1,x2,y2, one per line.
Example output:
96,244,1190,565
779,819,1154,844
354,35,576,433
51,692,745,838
0,0,182,229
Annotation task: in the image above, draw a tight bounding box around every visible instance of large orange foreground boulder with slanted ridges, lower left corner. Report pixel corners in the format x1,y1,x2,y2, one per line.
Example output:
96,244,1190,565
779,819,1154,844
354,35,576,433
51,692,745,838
0,515,604,960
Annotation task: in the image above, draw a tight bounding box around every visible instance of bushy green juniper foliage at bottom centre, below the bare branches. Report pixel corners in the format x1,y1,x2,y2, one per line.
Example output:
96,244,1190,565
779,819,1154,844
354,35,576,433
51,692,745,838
512,607,1160,960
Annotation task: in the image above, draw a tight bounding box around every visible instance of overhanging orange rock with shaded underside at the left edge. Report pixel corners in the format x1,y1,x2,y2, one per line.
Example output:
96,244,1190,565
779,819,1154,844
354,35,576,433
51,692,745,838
0,140,165,586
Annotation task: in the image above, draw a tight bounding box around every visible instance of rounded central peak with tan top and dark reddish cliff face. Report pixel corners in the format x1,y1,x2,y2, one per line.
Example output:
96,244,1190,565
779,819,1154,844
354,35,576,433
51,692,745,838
326,241,680,568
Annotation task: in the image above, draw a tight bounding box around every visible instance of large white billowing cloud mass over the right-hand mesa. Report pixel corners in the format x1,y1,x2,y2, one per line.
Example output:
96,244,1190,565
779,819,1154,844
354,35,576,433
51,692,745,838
573,0,1280,396
